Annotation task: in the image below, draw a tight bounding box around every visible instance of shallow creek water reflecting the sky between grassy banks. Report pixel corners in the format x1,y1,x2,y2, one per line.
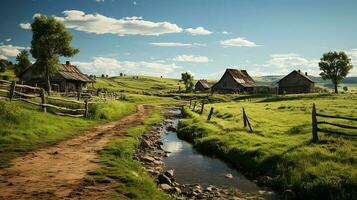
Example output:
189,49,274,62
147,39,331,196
161,109,278,200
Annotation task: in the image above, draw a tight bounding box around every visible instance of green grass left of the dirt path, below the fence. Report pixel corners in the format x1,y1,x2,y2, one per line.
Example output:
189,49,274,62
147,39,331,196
0,100,136,167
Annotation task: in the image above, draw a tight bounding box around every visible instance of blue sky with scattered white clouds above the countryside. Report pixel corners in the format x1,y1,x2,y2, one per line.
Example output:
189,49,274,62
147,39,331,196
0,0,357,79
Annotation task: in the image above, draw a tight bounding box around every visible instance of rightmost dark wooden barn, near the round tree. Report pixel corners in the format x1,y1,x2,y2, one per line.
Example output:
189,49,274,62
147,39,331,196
278,70,315,94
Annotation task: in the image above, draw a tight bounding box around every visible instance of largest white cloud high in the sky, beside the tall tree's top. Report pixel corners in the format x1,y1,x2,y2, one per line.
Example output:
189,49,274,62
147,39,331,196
52,10,182,36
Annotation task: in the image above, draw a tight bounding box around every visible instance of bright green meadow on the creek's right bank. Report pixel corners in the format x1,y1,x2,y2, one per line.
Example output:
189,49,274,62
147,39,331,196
179,94,357,199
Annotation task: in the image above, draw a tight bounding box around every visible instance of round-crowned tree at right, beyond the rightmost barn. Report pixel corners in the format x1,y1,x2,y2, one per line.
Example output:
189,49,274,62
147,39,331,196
319,51,353,93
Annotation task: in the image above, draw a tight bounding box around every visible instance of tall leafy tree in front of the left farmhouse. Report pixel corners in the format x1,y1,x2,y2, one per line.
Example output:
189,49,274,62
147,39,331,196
30,15,79,92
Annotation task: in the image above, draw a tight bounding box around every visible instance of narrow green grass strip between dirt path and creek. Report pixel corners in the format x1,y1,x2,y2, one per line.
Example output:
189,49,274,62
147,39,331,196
86,107,168,200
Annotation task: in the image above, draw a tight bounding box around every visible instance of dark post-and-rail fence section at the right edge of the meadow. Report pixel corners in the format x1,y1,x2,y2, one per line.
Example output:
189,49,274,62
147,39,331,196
312,104,357,142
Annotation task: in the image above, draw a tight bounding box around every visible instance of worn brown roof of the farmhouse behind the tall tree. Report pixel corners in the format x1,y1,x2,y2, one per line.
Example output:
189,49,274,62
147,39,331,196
20,64,94,82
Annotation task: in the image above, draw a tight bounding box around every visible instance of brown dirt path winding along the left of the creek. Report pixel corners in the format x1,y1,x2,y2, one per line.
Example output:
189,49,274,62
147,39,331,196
0,105,151,199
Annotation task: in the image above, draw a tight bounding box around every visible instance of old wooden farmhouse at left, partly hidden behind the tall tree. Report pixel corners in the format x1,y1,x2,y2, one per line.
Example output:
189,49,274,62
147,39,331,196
20,61,94,92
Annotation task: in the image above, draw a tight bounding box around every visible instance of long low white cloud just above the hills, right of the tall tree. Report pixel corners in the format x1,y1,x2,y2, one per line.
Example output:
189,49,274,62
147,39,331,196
72,57,182,76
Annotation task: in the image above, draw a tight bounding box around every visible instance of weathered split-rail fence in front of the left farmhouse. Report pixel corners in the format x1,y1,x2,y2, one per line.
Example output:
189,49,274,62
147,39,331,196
0,80,90,117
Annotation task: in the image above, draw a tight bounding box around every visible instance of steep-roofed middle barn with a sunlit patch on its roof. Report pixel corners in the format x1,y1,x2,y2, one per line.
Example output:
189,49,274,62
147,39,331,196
212,69,255,93
